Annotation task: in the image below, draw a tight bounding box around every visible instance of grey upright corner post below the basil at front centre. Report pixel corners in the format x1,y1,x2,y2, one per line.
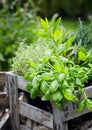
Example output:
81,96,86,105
52,103,68,130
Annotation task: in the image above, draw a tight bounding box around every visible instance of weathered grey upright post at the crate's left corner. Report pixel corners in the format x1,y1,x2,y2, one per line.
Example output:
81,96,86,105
7,74,20,130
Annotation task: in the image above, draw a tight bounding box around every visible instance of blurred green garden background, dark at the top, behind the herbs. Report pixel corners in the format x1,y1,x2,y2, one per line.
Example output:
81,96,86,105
0,0,92,71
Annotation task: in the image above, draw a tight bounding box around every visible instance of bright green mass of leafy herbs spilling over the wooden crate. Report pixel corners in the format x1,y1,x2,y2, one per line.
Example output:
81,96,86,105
13,18,92,112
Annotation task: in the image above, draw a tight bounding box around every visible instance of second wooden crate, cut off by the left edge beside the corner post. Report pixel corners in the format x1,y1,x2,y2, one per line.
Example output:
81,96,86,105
0,73,9,130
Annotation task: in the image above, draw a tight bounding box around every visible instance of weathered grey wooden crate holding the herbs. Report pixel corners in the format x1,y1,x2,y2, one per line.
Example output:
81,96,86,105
0,73,92,130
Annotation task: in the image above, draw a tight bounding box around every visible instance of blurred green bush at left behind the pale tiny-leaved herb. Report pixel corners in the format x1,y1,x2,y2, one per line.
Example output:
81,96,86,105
0,8,38,71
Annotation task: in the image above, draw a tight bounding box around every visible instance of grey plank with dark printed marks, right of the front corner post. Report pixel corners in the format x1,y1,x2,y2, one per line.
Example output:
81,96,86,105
63,86,92,121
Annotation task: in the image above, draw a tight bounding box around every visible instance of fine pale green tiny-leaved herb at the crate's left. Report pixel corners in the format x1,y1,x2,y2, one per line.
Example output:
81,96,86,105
12,39,49,75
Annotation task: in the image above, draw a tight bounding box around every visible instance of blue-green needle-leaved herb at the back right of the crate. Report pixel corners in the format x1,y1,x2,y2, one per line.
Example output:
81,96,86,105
76,21,92,49
